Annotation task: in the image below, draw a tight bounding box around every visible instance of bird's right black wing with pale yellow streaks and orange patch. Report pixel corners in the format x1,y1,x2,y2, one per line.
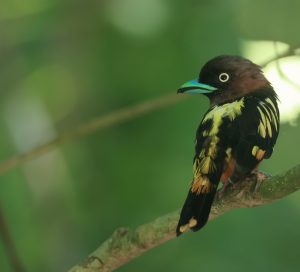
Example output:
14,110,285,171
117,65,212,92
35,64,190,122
231,97,279,182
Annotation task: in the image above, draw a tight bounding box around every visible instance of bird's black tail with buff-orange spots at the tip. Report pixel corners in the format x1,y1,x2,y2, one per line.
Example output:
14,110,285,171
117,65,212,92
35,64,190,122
176,186,217,236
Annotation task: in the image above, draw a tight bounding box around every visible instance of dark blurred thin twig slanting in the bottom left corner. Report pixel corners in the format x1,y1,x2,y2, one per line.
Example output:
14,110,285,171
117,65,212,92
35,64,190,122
0,205,25,272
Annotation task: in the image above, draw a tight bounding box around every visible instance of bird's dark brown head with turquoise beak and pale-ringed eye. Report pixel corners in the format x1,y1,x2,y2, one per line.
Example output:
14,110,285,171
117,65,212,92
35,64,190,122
177,55,274,105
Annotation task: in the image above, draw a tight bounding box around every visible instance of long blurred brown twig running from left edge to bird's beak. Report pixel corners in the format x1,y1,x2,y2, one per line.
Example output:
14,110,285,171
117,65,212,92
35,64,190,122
0,92,183,176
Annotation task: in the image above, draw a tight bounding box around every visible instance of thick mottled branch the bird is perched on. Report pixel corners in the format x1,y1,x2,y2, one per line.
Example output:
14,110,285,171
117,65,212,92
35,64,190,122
69,165,300,272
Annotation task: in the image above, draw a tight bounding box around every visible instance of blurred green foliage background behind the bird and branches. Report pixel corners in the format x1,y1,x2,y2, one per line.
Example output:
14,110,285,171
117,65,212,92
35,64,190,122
0,0,300,272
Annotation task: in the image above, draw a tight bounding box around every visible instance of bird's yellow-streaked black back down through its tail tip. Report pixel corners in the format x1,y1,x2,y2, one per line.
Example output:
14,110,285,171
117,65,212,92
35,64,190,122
177,100,243,235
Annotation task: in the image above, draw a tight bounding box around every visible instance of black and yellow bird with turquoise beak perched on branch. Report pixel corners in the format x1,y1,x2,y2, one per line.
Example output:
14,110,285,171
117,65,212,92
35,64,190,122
176,55,280,236
